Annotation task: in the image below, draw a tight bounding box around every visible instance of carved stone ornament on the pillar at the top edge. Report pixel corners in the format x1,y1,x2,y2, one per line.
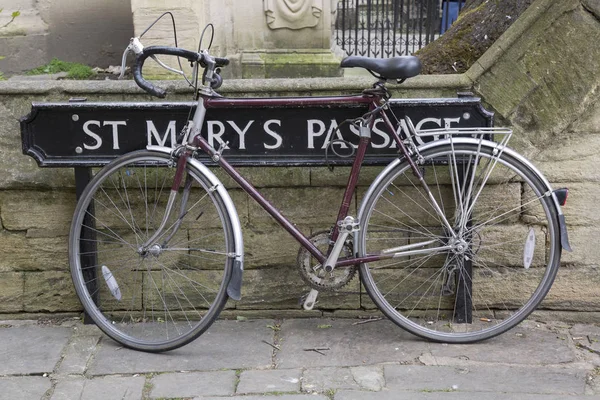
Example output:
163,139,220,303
264,0,323,30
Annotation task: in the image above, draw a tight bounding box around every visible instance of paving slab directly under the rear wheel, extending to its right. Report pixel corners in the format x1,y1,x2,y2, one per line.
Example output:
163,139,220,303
431,327,576,365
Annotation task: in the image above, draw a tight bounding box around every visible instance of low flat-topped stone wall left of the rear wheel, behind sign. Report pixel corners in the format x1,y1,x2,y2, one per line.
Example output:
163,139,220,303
0,76,468,317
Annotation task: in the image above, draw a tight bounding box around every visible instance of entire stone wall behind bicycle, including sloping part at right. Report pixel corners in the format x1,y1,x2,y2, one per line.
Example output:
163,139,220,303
0,0,600,321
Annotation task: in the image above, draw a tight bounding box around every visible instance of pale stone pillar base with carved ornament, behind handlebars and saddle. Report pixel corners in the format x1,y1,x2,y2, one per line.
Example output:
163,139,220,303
131,0,341,78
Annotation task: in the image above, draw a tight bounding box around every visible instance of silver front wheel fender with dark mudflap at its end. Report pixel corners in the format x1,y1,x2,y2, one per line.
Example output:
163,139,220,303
146,146,244,300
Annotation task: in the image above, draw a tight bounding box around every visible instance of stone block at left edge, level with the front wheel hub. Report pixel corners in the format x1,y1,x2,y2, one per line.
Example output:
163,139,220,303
0,231,69,271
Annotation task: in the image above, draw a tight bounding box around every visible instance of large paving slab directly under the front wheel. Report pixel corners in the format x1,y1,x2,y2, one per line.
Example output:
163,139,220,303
88,320,273,375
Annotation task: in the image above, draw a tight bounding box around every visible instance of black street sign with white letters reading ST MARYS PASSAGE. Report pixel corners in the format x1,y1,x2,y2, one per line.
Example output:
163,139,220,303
21,97,493,167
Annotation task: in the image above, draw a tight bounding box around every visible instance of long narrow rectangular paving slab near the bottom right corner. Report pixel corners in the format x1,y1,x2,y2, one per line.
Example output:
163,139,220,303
384,365,586,395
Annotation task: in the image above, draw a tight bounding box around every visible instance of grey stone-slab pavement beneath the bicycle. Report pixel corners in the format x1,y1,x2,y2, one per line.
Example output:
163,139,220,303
0,319,600,400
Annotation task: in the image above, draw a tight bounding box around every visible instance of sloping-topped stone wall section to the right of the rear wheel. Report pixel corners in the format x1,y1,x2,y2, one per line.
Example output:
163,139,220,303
466,0,600,321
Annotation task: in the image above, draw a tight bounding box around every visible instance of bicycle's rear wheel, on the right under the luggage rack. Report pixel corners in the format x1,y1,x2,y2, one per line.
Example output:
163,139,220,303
357,142,561,343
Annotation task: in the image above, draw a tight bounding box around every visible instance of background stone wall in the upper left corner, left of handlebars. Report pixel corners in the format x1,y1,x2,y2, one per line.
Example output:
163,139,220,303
0,0,133,73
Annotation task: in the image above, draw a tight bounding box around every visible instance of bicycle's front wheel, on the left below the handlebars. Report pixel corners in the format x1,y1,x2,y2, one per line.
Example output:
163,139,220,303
69,151,234,352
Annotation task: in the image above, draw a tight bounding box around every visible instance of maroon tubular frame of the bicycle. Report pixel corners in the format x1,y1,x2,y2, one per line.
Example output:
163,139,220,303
191,94,417,267
